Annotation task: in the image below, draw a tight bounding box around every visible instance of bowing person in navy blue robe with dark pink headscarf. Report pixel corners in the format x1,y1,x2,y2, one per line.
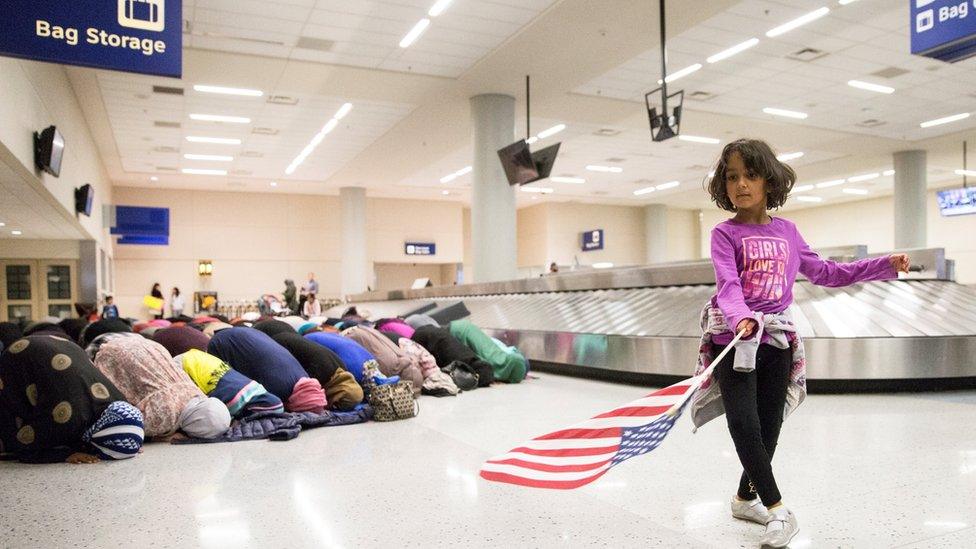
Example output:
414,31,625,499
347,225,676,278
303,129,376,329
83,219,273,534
207,328,326,412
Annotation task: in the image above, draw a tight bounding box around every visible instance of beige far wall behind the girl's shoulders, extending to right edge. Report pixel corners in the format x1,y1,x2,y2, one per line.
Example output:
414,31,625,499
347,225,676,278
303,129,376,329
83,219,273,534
701,191,976,284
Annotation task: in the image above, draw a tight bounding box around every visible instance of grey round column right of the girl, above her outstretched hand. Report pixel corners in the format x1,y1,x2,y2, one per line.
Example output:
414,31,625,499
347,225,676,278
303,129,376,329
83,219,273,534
894,151,928,249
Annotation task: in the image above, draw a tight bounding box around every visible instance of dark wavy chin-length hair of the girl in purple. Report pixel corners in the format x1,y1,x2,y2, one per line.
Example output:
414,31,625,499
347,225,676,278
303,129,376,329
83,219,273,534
707,139,796,212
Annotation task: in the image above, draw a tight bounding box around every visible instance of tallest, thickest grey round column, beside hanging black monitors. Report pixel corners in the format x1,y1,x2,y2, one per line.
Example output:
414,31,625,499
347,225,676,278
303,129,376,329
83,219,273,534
471,94,518,282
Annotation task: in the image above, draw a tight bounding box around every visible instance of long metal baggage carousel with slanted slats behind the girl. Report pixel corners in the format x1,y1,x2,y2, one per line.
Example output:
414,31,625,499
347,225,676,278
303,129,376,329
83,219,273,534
329,246,976,392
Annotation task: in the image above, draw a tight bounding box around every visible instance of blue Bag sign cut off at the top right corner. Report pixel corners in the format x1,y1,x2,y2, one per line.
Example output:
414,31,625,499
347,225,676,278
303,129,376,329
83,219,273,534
909,0,976,63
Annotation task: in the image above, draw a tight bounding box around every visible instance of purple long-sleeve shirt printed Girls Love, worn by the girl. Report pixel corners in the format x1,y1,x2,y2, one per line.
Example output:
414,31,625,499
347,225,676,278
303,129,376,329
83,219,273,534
712,217,898,345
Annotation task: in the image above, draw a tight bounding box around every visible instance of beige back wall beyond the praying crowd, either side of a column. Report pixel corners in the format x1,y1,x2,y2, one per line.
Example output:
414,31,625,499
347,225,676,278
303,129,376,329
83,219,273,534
113,187,463,317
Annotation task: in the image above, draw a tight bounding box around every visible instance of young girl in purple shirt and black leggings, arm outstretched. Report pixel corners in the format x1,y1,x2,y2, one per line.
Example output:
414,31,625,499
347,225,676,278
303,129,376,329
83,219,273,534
692,139,909,547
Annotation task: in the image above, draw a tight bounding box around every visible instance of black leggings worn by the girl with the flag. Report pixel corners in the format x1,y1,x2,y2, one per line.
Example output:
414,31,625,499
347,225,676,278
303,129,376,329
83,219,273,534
713,344,793,506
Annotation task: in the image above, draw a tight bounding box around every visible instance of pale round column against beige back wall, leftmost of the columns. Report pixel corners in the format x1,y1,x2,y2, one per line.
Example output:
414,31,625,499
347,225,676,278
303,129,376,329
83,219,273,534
339,187,370,296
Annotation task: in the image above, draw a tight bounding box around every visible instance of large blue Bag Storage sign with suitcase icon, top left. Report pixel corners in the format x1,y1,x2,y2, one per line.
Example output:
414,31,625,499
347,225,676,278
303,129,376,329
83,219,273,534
0,0,183,78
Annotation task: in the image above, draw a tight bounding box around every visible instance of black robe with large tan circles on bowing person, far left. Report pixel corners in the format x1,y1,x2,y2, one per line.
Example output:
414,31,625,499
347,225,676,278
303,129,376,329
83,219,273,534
0,335,124,461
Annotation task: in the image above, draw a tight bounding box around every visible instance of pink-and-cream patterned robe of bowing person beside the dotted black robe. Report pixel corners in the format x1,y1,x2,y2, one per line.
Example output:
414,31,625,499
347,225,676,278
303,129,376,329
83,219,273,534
95,336,212,437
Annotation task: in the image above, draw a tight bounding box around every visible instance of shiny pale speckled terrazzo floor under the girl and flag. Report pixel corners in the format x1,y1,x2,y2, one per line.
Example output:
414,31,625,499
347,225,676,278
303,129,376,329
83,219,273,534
0,374,976,549
